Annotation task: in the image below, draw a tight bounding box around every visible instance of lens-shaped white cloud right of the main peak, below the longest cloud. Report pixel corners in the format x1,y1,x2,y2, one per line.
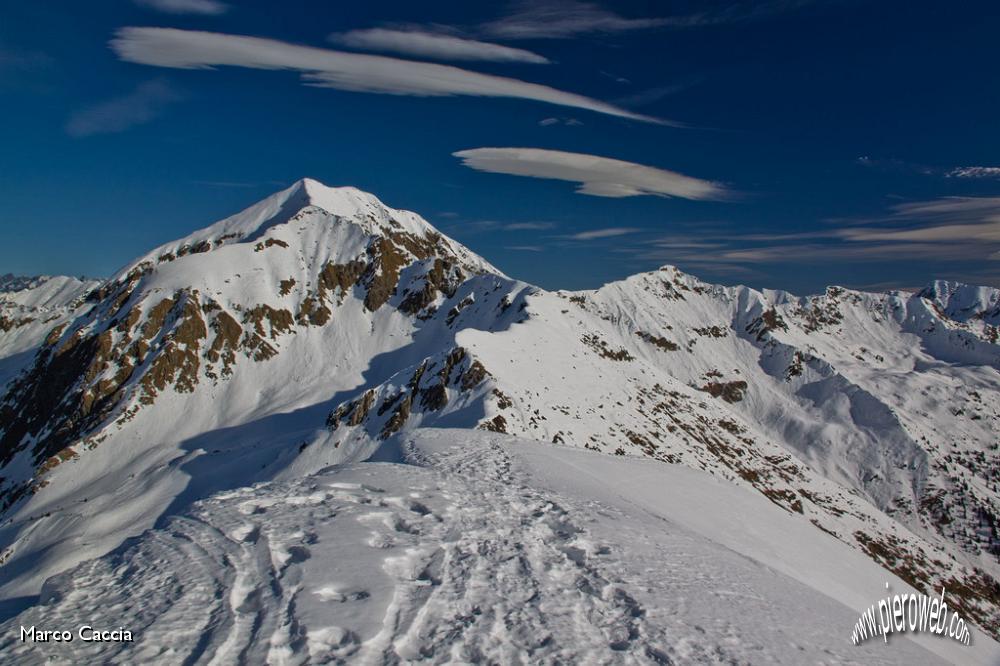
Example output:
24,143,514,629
452,148,728,199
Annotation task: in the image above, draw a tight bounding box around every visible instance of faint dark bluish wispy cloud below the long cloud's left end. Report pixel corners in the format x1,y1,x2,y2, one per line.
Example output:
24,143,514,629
66,80,181,137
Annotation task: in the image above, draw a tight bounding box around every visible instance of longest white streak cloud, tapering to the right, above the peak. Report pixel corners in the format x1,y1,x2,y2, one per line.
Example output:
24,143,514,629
111,27,671,124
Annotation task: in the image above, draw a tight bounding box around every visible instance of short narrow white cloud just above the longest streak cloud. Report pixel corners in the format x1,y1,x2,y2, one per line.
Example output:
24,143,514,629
330,28,549,65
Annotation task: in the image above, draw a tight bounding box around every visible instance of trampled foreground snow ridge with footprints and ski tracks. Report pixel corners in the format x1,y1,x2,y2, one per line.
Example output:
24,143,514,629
0,433,952,664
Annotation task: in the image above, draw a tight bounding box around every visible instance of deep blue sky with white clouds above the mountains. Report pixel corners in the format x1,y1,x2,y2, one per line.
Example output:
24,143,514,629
0,0,1000,292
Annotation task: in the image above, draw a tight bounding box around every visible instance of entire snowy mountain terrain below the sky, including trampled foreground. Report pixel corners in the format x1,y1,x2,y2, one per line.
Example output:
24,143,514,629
0,179,1000,664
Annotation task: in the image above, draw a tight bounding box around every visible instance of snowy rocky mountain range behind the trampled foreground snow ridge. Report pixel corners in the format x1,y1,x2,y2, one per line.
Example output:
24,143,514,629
0,179,1000,660
